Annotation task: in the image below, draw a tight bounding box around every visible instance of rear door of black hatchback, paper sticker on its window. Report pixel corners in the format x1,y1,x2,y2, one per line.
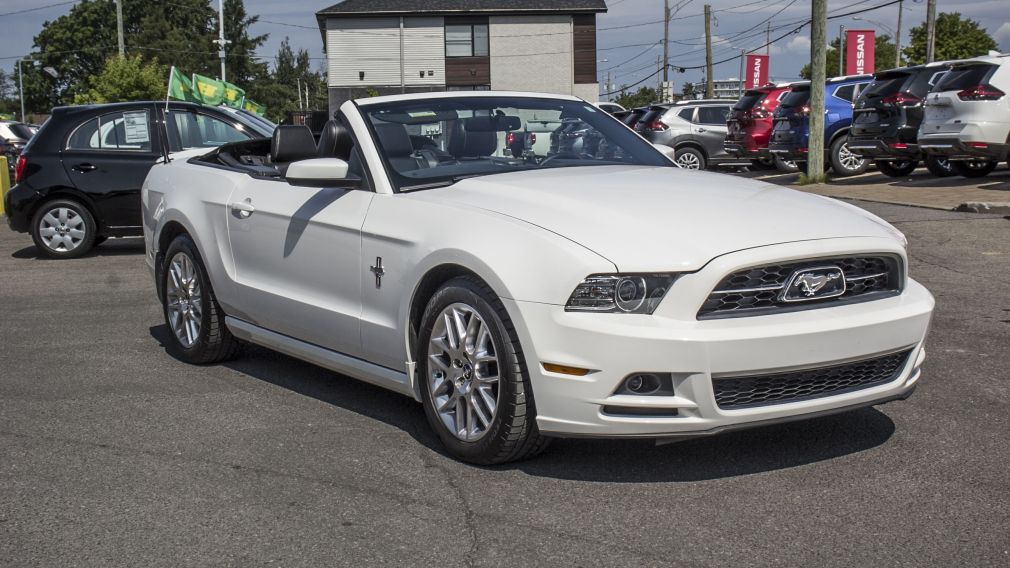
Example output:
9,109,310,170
61,104,162,231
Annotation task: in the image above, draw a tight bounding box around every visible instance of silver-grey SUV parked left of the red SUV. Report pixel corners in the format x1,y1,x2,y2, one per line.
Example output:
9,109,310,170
635,99,750,170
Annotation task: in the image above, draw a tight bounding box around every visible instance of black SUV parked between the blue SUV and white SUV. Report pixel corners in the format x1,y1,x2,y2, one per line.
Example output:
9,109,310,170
848,62,952,178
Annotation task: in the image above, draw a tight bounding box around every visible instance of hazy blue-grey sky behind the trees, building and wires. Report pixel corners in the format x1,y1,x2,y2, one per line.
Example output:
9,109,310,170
0,0,1010,97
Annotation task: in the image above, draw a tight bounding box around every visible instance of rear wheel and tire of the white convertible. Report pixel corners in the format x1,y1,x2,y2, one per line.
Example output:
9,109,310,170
162,234,239,365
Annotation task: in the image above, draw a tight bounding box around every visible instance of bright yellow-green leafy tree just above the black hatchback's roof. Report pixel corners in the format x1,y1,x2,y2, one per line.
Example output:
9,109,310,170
74,56,168,104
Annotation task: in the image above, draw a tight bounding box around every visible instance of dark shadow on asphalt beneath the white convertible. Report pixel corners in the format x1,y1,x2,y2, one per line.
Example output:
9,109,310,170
150,324,895,483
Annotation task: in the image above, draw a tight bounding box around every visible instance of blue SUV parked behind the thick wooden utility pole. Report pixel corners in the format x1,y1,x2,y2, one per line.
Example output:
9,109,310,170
769,75,874,176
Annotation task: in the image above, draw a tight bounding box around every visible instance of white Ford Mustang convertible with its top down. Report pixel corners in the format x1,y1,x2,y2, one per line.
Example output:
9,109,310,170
143,92,933,464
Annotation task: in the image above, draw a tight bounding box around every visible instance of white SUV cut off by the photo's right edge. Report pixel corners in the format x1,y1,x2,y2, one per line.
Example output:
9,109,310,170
919,54,1010,178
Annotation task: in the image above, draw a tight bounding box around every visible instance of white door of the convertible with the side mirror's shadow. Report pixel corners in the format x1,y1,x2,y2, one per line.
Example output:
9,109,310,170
225,146,374,357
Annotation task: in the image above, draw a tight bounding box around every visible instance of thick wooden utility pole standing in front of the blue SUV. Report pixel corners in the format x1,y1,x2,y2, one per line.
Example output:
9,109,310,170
807,0,827,183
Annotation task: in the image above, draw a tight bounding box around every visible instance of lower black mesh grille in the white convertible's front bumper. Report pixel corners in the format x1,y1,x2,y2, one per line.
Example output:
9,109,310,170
712,349,912,408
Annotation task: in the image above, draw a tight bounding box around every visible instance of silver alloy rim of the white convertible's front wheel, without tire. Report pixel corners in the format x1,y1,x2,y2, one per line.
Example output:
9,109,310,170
427,303,500,442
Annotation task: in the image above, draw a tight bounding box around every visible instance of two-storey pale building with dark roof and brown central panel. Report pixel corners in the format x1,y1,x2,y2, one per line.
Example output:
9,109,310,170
316,0,607,112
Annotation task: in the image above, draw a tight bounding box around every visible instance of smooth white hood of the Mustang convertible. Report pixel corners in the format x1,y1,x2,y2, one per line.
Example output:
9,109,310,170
411,166,896,272
